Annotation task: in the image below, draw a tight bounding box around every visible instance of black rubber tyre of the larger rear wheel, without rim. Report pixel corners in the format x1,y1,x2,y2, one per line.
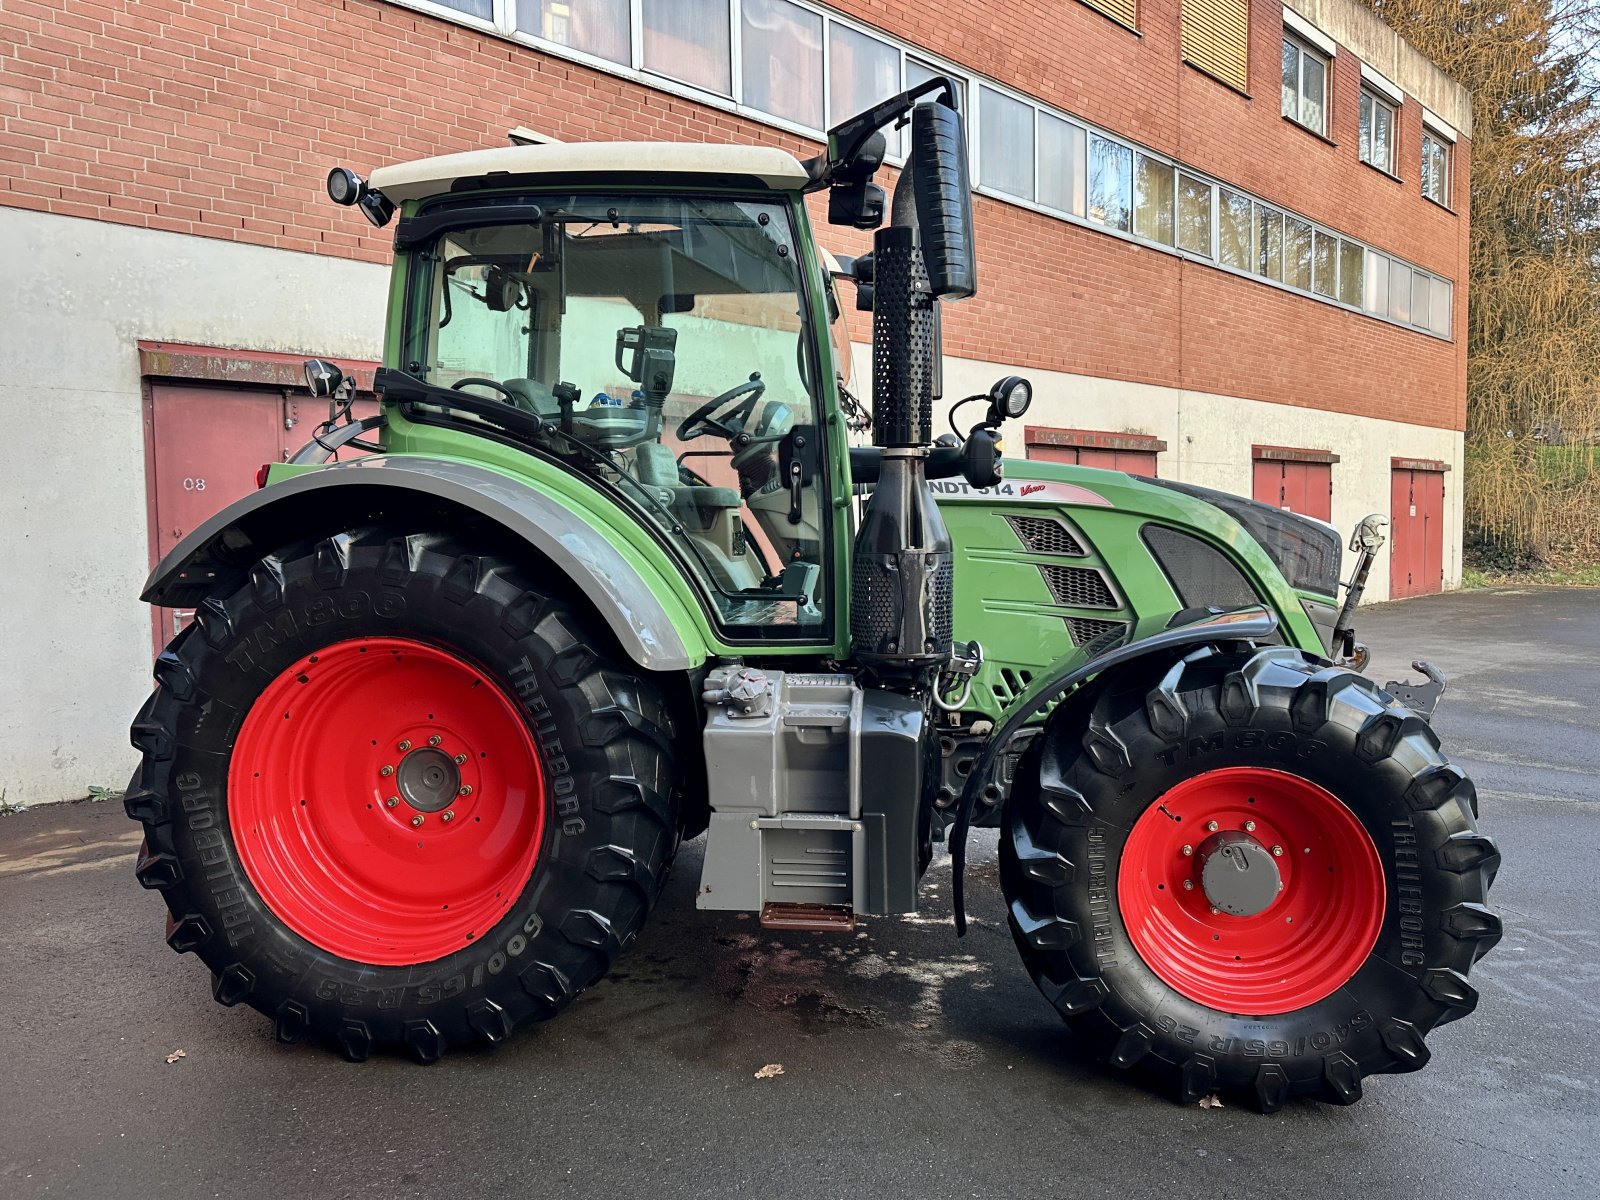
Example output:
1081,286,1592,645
126,530,678,1062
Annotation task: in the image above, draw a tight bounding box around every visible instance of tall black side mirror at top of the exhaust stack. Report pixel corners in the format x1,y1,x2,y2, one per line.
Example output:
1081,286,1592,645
909,101,978,299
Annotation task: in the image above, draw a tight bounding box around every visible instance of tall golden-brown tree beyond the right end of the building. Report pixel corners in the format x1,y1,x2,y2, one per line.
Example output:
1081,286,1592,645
1366,0,1600,566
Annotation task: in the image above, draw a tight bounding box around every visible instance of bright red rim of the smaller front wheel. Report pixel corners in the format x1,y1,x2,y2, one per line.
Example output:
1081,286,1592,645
1117,766,1387,1016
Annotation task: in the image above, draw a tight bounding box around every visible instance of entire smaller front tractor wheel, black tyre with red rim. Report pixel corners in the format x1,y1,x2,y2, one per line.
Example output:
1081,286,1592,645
1000,648,1501,1110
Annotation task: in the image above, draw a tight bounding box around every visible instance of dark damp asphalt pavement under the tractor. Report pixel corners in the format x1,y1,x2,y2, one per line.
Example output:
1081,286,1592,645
0,589,1600,1200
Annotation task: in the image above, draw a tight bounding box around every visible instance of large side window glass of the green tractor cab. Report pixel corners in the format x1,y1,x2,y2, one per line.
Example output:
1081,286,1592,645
406,194,829,638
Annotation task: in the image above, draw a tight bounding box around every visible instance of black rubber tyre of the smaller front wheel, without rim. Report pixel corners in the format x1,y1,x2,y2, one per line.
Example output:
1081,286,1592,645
1000,648,1501,1112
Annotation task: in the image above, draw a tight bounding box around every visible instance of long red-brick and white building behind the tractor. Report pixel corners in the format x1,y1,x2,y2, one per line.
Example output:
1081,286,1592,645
0,0,1470,802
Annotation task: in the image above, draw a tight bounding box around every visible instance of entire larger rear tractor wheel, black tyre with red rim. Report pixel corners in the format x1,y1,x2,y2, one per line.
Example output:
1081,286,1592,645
126,530,677,1061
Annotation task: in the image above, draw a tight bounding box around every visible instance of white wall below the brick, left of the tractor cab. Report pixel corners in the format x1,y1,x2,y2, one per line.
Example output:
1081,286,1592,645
0,206,386,805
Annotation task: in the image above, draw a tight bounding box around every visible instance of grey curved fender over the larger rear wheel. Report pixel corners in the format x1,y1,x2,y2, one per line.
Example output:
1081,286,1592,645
139,454,706,670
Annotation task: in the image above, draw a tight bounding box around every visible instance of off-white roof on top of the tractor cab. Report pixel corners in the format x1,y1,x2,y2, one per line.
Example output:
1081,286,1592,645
371,142,806,203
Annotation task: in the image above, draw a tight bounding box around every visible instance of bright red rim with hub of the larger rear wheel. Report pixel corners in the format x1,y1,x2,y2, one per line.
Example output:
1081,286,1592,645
227,637,546,966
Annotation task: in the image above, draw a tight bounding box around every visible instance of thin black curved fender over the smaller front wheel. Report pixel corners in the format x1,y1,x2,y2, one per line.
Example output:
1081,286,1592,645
950,605,1278,934
